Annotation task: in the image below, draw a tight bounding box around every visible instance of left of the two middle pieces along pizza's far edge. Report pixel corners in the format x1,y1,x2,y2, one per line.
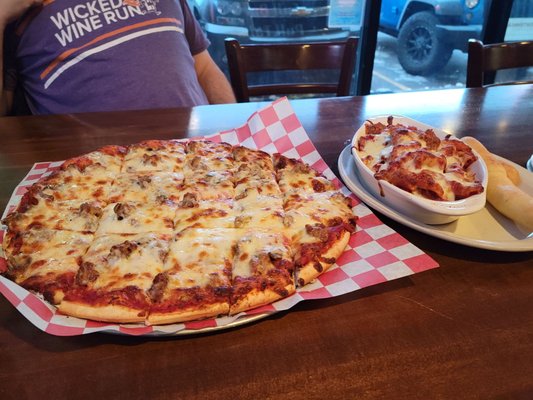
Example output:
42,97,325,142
122,140,185,173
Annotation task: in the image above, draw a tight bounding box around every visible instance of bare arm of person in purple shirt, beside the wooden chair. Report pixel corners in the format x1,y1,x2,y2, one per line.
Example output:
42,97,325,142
194,50,236,104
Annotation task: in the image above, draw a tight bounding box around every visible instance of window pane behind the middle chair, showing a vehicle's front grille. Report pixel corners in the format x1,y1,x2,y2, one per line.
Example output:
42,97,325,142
188,0,364,96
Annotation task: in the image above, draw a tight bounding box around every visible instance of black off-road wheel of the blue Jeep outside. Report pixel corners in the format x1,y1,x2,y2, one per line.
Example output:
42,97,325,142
398,11,453,75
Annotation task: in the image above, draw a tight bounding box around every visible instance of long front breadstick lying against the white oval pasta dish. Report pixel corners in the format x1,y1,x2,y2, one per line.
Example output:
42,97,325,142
461,136,533,231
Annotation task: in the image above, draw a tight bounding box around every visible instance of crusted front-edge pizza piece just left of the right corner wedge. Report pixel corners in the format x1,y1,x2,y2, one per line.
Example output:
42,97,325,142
230,229,296,314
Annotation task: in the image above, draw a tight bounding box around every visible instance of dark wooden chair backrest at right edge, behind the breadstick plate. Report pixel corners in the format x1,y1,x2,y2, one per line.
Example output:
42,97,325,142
466,39,533,87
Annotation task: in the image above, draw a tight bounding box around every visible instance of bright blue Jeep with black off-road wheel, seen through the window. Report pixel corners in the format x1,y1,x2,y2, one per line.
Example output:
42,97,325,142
379,0,485,76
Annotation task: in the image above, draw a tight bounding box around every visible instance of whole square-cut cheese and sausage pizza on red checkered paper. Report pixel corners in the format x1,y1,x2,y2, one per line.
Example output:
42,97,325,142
2,140,357,325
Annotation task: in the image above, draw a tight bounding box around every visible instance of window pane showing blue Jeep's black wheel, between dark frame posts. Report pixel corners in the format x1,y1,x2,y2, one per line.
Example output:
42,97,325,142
371,0,486,93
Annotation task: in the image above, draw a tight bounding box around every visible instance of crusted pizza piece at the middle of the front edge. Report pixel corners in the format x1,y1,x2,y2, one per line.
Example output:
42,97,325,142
148,228,237,325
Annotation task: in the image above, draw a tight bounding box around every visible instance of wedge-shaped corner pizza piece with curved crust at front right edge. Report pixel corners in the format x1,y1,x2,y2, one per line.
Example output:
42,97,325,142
284,192,356,286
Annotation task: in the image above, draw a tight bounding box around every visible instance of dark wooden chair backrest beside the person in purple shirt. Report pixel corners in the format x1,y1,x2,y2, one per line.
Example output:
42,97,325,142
225,37,358,103
